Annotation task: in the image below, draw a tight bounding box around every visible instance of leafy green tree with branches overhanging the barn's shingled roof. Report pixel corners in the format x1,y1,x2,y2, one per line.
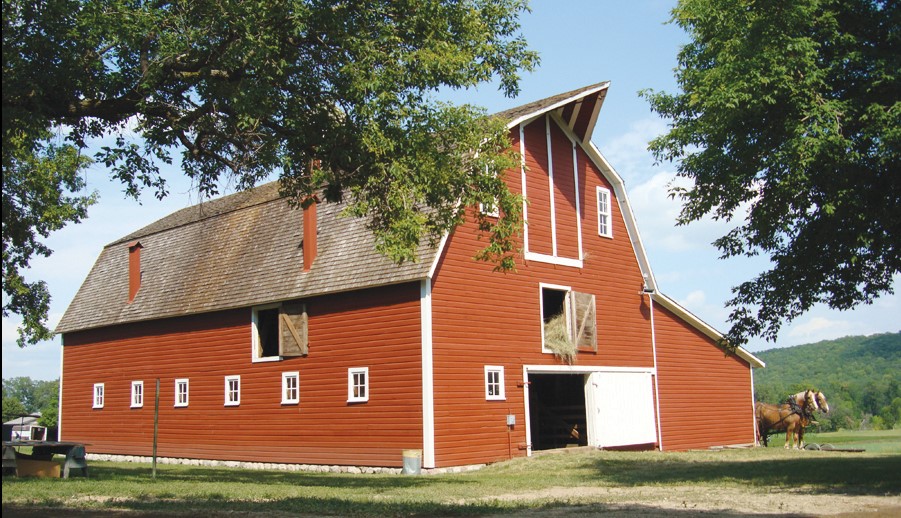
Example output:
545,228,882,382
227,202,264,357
2,0,537,350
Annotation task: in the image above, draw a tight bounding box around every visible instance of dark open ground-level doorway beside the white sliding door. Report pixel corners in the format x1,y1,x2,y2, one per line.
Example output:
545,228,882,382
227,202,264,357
529,373,588,451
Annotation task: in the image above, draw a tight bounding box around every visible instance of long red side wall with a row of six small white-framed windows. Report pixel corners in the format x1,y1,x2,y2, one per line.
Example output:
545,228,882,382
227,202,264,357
62,283,422,466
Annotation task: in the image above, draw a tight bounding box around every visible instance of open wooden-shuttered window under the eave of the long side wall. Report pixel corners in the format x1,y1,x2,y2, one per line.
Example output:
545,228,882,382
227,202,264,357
252,302,307,361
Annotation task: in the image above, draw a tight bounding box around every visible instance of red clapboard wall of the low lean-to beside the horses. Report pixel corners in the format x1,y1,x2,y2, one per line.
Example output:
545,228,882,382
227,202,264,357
654,305,754,450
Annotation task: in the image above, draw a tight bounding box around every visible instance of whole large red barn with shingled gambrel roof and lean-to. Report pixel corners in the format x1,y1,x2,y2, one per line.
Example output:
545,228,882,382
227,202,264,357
57,83,762,468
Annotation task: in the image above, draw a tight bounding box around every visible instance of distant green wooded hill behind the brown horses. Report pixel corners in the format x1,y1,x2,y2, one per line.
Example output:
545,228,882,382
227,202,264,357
754,332,901,431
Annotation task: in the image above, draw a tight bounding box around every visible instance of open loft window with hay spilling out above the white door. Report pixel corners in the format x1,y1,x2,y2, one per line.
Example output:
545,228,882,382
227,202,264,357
541,284,598,363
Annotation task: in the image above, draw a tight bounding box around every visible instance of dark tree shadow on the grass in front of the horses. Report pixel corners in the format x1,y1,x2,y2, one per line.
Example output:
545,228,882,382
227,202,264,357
589,458,901,496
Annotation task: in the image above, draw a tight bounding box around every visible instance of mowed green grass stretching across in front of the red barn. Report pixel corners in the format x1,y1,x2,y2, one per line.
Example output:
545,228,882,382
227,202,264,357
3,431,901,516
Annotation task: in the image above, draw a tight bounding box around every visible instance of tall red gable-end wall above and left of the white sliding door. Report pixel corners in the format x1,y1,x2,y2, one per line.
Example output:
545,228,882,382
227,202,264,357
432,118,654,466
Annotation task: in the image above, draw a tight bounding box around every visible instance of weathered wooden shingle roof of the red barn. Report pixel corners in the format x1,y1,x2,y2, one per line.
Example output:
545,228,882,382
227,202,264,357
56,83,609,333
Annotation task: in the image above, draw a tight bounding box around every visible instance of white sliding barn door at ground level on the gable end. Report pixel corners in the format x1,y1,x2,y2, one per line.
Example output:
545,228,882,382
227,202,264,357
585,372,657,448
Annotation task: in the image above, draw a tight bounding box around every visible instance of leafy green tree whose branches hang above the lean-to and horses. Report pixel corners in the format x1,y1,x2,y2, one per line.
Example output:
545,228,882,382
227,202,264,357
643,0,901,346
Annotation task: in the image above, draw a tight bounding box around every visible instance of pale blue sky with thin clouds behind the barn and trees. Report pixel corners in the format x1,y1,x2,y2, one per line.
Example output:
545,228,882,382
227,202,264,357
3,0,901,379
